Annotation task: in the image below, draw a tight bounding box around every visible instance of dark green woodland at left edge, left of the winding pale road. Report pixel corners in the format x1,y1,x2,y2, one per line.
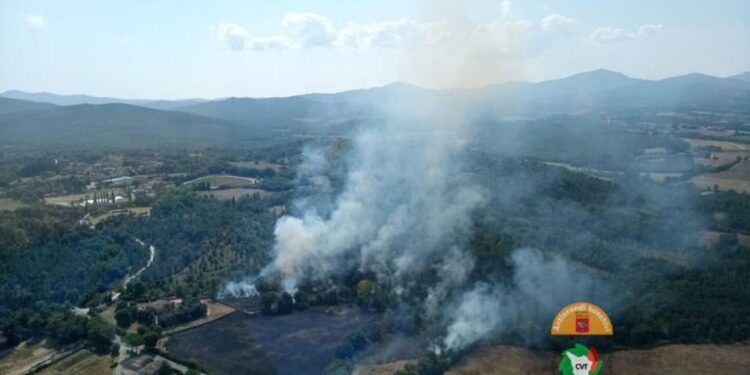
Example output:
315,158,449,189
0,205,148,352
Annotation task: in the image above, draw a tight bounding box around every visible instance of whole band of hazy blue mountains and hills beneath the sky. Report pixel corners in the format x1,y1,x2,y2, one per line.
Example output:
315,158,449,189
0,69,750,151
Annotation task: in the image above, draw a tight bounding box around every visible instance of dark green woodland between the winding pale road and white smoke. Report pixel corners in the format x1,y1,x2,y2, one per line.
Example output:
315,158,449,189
102,189,283,299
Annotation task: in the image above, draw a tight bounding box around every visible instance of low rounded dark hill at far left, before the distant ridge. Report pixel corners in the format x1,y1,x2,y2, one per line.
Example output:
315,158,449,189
0,104,259,149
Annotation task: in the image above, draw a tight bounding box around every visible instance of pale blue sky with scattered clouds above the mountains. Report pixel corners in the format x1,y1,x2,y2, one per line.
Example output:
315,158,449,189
0,0,750,98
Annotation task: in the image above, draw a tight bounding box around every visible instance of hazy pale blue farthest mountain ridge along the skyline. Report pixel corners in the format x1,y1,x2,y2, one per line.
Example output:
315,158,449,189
0,69,750,114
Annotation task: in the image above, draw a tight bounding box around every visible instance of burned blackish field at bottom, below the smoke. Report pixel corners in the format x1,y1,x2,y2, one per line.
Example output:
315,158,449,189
167,307,377,375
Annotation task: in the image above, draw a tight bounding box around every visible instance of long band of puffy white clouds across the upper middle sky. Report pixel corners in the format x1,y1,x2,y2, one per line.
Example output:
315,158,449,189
218,1,588,58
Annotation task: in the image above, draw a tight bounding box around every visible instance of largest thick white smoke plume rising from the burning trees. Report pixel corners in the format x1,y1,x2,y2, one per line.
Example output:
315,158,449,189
266,96,482,291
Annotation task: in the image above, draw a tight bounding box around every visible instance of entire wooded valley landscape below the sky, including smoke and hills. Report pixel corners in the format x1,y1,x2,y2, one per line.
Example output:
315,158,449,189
0,71,750,375
